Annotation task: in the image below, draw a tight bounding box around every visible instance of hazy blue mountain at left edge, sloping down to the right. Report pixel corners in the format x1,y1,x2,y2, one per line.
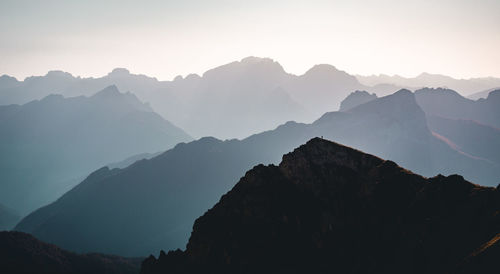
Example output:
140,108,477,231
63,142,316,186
0,86,191,215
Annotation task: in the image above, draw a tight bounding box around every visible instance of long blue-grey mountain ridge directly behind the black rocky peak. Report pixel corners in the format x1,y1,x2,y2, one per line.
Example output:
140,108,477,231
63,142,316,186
15,90,500,256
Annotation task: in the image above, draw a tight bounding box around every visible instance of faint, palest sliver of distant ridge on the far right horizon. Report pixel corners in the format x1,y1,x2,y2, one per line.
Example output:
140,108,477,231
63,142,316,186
356,73,500,96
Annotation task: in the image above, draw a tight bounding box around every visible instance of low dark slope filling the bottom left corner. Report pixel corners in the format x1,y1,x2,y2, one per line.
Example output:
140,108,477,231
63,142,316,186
0,231,140,274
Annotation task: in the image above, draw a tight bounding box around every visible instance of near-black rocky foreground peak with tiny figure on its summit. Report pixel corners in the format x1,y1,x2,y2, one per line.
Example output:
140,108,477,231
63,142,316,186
142,138,500,274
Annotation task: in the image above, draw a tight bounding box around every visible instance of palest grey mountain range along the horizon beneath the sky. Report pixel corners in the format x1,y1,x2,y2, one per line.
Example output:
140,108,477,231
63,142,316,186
0,57,500,139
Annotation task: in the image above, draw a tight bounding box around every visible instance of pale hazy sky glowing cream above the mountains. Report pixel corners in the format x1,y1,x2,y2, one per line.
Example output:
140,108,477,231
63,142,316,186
0,0,500,80
